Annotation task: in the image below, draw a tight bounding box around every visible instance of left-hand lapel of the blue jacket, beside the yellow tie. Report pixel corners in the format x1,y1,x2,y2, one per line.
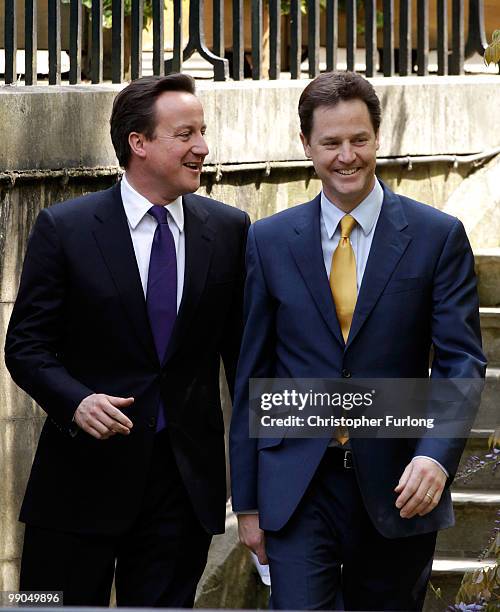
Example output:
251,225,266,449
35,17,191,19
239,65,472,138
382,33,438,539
289,195,344,345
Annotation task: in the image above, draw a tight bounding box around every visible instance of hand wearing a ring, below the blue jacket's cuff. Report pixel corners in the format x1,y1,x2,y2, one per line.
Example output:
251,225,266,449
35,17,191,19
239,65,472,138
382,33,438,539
394,457,446,518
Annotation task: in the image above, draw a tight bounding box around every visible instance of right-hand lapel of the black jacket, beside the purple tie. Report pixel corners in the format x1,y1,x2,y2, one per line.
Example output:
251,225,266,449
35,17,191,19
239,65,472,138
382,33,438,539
165,194,215,362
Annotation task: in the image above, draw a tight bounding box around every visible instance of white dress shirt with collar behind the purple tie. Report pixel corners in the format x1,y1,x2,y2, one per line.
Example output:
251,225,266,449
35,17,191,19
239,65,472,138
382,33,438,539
120,174,186,312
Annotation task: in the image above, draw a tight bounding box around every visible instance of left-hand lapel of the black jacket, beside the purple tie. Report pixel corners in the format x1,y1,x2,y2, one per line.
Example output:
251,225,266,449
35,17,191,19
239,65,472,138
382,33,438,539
94,183,158,362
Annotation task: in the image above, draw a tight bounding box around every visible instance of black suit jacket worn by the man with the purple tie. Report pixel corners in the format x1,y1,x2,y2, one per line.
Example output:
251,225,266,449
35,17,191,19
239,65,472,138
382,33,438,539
5,184,249,535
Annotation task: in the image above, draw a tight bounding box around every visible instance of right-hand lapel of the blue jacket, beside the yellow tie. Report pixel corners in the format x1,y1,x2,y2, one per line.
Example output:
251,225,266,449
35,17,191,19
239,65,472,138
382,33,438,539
346,184,411,348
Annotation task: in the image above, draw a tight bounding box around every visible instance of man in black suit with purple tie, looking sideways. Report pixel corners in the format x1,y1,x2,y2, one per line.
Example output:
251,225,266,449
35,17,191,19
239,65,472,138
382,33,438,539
5,75,249,607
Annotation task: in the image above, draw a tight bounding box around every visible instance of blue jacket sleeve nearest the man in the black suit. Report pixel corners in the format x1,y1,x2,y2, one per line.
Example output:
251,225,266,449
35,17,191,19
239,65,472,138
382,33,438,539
229,225,275,512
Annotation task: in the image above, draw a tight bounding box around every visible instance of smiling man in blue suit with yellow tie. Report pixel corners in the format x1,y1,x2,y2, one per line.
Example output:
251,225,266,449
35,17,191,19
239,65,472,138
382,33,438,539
230,72,486,610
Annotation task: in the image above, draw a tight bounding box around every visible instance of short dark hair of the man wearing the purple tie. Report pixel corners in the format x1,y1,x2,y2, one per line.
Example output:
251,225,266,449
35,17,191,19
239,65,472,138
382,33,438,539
109,73,195,168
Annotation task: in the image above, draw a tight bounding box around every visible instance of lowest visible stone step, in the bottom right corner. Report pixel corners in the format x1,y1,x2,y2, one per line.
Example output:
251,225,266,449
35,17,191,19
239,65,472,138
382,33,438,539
423,558,495,612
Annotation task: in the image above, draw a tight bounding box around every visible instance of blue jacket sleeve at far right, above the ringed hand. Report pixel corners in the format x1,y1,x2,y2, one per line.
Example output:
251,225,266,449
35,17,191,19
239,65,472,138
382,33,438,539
415,219,486,484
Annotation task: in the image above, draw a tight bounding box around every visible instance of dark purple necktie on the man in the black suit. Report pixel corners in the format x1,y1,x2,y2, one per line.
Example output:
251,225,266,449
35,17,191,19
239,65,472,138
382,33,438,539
146,205,177,432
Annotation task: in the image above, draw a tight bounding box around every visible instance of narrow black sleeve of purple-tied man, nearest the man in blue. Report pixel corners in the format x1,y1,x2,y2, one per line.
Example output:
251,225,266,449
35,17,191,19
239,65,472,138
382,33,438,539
220,213,250,401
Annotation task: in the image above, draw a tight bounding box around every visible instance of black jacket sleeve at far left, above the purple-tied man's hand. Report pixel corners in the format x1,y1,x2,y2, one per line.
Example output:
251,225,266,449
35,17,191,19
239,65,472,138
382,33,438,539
5,209,93,433
